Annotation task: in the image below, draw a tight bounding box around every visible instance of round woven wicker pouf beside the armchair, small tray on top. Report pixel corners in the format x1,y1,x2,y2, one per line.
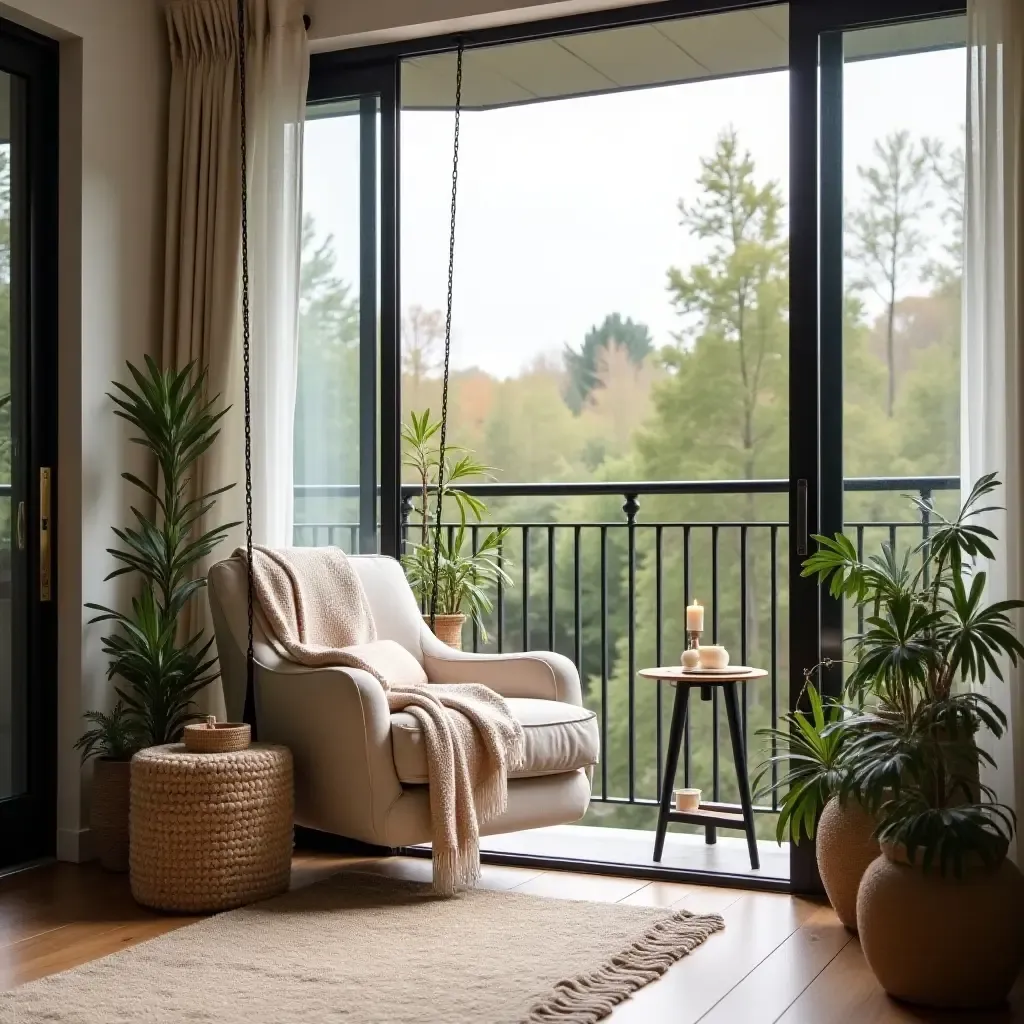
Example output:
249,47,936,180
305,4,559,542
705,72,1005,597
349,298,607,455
130,743,293,912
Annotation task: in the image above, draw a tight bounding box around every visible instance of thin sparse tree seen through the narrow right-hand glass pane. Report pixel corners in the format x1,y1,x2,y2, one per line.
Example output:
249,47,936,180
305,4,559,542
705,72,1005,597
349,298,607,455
847,131,932,419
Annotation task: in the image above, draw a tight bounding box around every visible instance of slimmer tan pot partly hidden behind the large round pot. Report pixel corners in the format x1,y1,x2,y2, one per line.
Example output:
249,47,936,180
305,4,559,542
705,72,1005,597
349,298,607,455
816,797,879,932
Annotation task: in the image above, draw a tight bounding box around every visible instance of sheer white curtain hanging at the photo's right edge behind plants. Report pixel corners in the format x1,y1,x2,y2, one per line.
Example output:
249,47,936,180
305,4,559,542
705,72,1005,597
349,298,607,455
961,0,1024,864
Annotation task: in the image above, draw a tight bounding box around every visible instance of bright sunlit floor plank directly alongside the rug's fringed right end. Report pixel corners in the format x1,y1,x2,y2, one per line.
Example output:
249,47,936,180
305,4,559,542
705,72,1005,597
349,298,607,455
609,893,818,1024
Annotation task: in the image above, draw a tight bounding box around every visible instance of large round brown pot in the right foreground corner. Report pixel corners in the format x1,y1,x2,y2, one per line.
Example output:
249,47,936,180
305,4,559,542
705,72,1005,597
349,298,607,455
857,848,1024,1010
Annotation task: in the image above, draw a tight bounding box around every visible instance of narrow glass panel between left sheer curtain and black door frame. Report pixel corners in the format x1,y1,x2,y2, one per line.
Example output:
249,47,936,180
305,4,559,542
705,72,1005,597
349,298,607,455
295,97,380,552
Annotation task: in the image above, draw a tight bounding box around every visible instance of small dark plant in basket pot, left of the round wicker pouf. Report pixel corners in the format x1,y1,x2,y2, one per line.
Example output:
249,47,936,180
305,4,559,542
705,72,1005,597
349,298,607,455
75,700,142,871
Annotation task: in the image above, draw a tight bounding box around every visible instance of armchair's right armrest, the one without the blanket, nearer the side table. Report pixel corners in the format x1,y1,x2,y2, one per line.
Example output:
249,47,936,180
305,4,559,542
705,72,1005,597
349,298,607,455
420,626,583,706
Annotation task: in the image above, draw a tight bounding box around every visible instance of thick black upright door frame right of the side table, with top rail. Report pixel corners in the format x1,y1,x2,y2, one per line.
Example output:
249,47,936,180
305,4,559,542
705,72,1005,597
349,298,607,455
790,0,967,892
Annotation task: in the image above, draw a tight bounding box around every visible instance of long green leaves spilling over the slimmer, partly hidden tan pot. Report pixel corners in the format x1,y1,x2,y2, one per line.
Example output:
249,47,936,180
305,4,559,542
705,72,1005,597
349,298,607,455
752,681,846,843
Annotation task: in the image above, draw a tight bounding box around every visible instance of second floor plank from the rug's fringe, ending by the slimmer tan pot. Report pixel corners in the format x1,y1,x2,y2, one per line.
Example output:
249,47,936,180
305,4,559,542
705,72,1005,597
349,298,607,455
700,903,853,1024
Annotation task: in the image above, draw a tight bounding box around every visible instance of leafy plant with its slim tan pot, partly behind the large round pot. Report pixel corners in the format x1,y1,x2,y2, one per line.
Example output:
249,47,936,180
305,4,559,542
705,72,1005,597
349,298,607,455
754,675,879,932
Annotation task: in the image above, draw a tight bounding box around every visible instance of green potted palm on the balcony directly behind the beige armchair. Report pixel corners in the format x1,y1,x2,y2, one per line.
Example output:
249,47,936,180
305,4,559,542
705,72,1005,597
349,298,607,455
401,409,512,649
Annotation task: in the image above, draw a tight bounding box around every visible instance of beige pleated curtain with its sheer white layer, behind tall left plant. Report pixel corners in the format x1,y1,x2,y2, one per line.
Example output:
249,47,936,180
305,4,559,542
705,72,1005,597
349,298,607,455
162,0,309,715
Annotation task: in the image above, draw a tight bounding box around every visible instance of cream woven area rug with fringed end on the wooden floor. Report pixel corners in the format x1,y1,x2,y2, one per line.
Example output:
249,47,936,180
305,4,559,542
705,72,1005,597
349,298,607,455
0,871,724,1024
